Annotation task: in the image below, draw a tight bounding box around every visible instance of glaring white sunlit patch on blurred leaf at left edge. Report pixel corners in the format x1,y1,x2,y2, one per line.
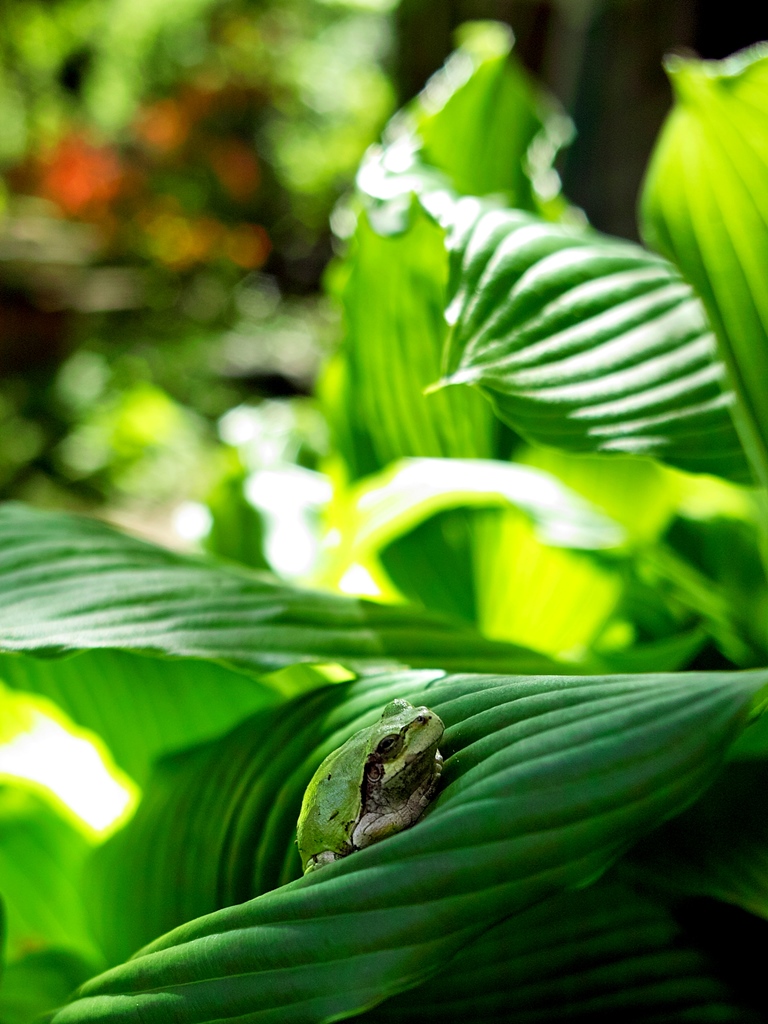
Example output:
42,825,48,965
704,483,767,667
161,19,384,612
0,711,136,833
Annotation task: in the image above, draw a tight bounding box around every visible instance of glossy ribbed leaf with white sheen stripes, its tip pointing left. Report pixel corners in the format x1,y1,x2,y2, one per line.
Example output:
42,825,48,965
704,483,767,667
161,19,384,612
442,200,749,480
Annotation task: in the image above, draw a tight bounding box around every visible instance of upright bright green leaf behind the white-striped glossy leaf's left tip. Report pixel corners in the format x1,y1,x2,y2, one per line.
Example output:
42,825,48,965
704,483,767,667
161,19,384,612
322,209,500,478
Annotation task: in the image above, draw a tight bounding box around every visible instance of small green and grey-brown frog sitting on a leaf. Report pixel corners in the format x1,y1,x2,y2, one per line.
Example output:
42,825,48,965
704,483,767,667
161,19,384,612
297,698,444,874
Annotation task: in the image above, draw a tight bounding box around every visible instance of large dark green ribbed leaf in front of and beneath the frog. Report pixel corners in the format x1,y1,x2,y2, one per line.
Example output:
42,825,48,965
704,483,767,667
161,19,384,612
53,671,768,1024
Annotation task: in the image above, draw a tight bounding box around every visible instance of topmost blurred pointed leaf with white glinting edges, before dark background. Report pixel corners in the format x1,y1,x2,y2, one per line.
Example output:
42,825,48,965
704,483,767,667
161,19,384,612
356,22,573,234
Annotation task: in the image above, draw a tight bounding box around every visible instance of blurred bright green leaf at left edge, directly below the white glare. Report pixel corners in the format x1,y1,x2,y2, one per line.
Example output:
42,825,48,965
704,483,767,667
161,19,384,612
0,784,102,970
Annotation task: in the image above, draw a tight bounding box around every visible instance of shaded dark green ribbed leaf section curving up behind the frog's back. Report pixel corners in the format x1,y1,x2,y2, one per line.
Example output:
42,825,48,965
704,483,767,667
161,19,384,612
89,672,441,962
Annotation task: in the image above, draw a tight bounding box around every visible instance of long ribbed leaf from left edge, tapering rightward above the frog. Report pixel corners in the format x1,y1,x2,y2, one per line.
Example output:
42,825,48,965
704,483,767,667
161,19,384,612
0,505,557,679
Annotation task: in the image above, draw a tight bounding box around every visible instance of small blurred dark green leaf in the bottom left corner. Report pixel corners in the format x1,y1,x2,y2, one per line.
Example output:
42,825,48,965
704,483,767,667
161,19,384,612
0,949,93,1024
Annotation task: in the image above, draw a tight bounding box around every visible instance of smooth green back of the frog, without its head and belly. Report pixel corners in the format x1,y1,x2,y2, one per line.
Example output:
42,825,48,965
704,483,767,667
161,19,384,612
297,735,369,865
